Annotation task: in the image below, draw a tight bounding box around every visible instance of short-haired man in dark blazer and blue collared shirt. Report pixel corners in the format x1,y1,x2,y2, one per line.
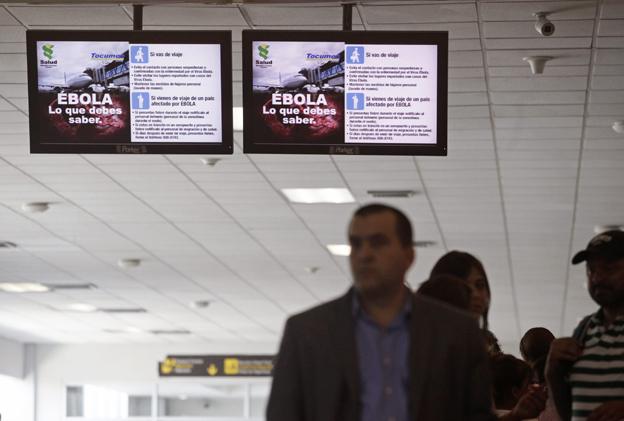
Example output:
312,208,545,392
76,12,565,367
267,204,495,421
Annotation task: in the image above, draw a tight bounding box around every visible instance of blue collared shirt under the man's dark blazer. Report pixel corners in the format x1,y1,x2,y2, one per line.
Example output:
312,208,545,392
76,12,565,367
353,294,412,421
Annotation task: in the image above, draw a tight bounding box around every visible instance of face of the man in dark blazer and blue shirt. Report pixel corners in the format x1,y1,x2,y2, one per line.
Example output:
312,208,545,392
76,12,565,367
349,211,414,296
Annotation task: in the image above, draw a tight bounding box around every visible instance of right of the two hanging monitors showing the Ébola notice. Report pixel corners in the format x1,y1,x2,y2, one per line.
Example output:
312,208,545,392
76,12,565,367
243,30,448,155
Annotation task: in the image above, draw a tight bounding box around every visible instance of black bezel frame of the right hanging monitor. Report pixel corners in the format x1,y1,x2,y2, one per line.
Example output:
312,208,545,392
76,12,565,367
242,30,448,156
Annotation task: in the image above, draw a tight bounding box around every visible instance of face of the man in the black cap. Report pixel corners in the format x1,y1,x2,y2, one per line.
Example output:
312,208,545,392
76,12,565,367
587,257,624,307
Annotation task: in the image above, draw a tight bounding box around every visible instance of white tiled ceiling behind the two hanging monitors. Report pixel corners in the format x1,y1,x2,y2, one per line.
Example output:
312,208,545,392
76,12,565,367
0,0,624,351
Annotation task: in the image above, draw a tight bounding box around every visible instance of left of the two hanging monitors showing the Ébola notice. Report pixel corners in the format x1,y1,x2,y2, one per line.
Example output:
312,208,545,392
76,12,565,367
27,30,232,154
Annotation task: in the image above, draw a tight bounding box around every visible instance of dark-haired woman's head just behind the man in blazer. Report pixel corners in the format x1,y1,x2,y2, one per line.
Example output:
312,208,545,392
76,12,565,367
429,250,491,330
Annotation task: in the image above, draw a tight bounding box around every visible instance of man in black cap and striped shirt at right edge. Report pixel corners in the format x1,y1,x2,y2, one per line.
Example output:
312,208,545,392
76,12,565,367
546,231,624,421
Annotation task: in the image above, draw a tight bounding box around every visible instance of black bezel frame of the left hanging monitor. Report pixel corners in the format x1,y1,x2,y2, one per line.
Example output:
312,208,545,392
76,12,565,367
26,30,234,155
